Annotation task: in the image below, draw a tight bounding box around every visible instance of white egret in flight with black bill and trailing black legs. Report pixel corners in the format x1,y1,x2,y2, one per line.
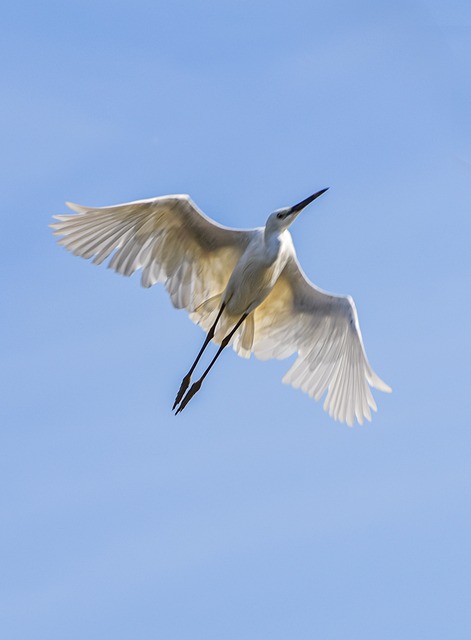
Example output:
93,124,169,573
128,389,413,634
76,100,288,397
51,189,391,426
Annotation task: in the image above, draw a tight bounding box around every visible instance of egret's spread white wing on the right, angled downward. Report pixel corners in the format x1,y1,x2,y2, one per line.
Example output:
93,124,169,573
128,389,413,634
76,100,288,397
253,256,391,426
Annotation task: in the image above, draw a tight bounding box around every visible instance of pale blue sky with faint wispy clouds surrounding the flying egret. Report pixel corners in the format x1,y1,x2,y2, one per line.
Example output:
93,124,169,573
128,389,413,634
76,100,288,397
0,0,471,640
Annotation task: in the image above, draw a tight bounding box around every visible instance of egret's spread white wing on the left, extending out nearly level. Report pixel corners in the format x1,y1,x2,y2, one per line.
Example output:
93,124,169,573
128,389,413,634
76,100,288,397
51,195,250,314
